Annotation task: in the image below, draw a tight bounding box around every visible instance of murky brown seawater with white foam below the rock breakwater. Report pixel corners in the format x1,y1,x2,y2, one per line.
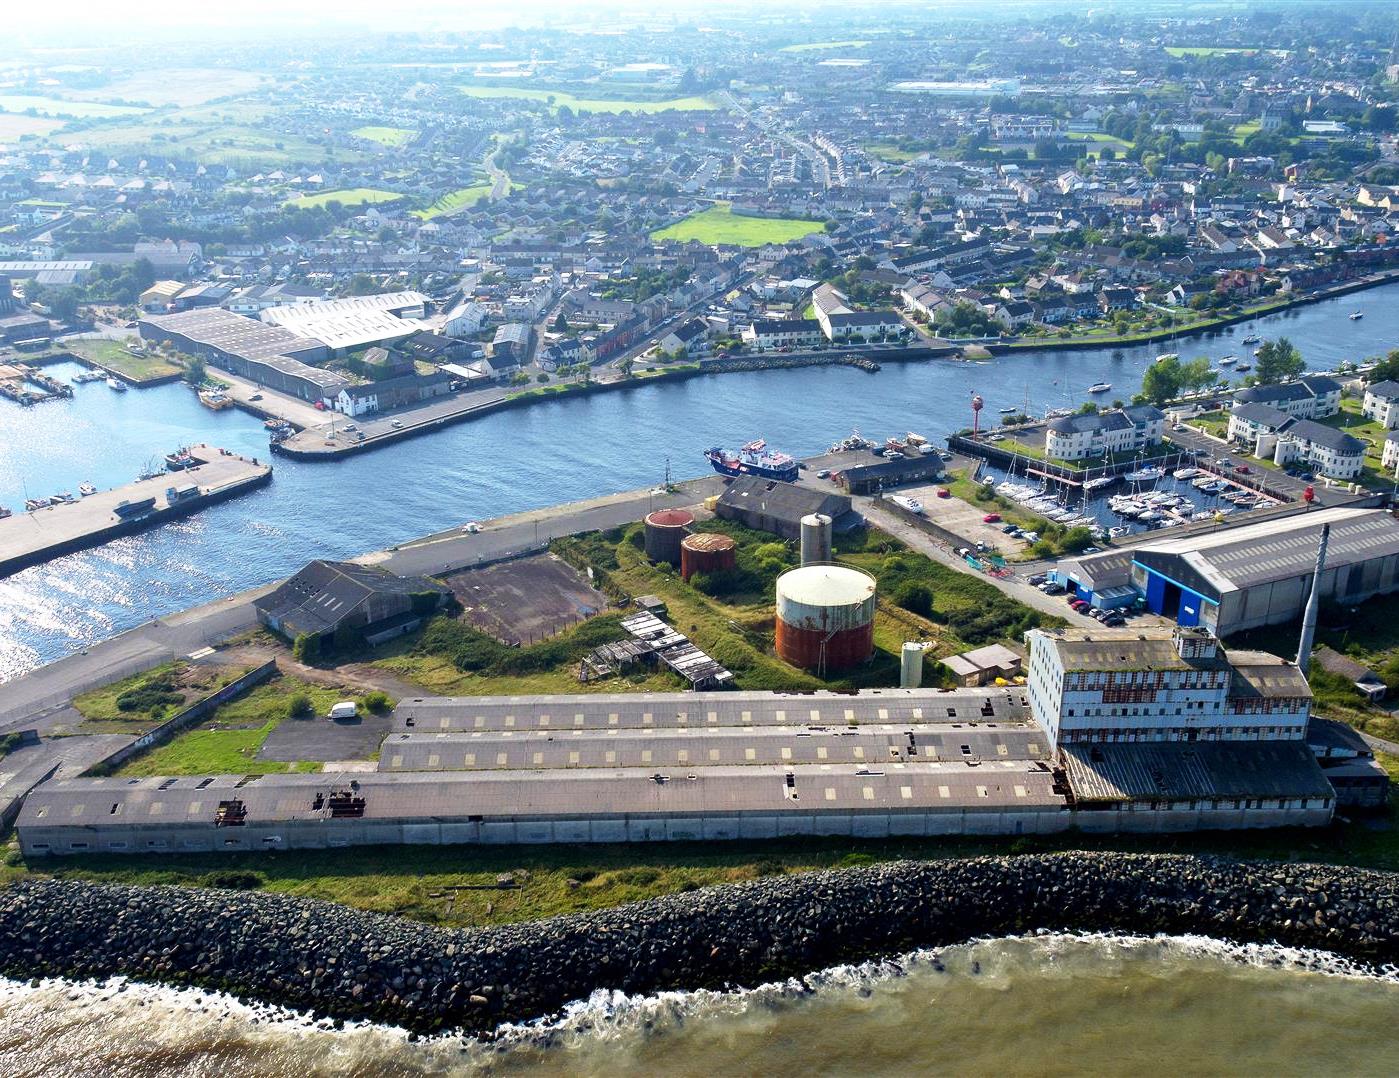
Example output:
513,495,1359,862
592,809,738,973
8,933,1399,1078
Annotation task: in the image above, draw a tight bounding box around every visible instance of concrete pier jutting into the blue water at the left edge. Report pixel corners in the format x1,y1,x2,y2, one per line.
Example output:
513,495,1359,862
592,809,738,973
0,445,271,577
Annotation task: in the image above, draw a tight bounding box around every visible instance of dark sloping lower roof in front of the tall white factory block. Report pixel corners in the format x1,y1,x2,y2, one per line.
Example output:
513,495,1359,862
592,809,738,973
1062,741,1333,801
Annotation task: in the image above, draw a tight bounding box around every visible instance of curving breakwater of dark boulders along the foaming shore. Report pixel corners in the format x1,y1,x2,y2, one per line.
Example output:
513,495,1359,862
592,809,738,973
0,853,1399,1032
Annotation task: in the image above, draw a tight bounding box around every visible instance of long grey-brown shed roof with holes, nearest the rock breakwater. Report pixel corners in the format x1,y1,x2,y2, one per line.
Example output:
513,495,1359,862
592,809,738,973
18,761,1065,835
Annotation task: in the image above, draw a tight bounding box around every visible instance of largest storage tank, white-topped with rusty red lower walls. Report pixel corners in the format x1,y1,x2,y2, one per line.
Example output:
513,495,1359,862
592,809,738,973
776,565,874,673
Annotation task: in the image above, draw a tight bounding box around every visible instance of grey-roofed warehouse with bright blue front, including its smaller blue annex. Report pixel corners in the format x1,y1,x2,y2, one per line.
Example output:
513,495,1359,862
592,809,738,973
1058,508,1399,636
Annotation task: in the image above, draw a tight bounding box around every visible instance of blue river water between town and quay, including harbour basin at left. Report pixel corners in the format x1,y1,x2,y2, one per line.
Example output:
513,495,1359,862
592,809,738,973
0,285,1399,681
